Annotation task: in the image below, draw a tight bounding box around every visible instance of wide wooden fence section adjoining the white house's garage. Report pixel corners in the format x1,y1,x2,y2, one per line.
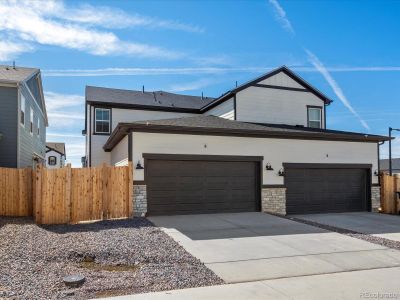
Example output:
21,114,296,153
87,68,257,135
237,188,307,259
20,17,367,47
34,163,133,224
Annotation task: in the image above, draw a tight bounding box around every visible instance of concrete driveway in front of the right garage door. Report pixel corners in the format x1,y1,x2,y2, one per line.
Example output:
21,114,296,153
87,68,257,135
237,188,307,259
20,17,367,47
294,212,400,242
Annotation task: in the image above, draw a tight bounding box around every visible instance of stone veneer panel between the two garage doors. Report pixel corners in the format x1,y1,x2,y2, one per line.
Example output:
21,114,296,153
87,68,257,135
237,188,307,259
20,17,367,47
261,187,286,215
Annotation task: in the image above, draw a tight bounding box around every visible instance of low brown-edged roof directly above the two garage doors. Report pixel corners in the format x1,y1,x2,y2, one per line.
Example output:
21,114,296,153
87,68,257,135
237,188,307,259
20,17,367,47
103,115,389,151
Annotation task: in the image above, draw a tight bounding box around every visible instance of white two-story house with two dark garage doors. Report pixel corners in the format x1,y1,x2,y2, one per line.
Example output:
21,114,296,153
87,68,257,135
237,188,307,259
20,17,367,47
83,67,388,215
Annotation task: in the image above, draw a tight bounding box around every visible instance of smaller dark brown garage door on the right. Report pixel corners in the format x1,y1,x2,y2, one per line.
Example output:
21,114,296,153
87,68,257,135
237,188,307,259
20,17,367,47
285,165,369,214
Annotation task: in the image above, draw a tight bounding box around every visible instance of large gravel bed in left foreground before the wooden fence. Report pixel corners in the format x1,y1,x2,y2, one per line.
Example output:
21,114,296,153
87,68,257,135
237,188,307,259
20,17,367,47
0,218,223,300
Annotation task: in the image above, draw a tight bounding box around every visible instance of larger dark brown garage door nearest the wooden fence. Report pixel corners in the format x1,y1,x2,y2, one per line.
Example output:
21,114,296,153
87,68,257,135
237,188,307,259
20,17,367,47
146,157,260,215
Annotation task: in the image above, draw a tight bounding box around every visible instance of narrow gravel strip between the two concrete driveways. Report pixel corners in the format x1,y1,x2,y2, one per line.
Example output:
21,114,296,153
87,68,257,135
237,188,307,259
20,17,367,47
285,217,400,250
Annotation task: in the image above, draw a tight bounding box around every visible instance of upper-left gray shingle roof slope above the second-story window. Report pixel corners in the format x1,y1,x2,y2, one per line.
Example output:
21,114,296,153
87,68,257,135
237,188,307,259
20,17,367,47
85,86,214,112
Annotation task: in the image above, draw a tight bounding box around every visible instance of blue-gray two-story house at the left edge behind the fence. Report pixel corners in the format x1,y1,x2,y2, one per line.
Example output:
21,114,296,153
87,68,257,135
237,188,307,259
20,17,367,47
0,66,48,168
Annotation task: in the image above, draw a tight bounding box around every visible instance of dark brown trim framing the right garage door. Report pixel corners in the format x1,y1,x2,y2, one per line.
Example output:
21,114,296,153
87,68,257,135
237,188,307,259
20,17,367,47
282,163,372,212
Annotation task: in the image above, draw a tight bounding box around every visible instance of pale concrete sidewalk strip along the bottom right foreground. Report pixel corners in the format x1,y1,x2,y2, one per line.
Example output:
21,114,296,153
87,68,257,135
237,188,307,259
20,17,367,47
97,266,400,300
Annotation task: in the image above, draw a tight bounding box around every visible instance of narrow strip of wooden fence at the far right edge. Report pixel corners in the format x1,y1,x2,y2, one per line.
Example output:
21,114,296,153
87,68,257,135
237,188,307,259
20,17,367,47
381,174,400,214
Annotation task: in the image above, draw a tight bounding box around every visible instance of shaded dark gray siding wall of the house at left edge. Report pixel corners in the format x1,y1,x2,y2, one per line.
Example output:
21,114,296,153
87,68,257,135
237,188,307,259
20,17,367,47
0,87,18,168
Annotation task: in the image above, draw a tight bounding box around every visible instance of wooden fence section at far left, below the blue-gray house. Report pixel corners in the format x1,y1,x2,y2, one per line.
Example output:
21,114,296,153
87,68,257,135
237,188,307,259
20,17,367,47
0,168,32,217
